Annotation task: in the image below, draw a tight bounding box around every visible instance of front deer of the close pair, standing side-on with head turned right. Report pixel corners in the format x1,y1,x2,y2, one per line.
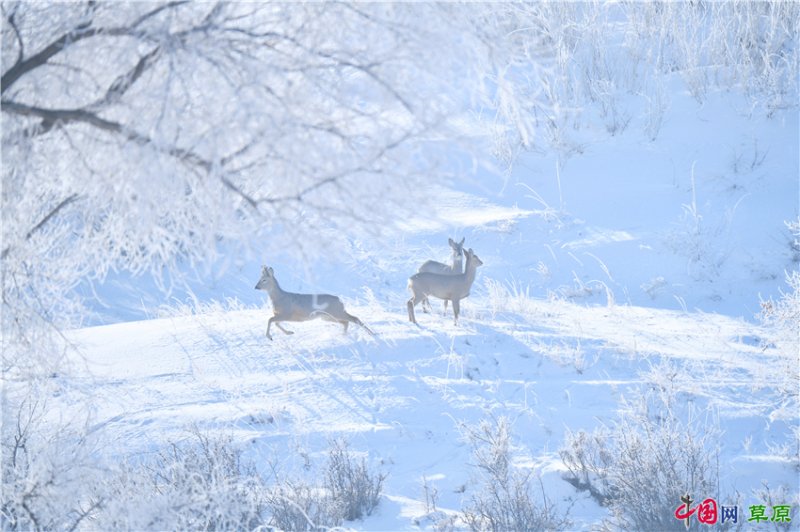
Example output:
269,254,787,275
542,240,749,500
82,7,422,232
408,249,483,324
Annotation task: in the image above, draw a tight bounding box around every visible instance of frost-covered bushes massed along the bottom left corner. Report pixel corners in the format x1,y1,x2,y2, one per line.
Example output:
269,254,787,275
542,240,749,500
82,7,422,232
0,424,386,530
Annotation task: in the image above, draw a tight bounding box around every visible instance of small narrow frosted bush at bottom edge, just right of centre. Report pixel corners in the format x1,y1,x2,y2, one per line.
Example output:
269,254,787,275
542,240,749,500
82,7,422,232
462,418,570,531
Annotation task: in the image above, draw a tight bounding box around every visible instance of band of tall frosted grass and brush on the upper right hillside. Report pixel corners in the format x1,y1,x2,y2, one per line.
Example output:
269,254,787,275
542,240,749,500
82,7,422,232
465,1,800,159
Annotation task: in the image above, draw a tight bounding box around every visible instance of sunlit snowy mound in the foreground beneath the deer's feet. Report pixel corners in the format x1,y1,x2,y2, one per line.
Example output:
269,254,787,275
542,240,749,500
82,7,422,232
65,294,797,530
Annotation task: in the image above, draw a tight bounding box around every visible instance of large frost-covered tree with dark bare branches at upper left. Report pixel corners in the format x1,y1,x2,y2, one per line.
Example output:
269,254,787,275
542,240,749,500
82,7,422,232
1,1,484,378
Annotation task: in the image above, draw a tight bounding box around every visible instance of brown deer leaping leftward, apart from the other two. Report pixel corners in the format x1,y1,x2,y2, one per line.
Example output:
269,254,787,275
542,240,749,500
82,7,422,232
256,266,375,340
